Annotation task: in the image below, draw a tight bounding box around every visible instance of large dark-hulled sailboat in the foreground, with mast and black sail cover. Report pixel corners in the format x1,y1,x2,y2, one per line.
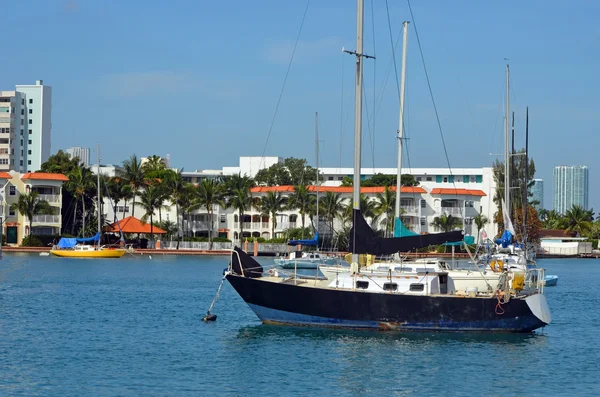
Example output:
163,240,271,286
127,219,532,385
225,0,551,332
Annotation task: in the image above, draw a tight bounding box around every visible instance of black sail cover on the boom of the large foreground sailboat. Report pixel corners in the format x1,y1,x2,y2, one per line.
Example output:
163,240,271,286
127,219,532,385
349,209,463,255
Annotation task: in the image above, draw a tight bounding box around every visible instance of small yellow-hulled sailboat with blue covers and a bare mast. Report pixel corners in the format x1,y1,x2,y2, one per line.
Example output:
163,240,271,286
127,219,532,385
50,147,127,258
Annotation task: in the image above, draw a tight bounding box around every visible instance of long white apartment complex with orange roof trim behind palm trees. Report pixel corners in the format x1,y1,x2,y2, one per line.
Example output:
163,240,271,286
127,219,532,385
99,157,497,241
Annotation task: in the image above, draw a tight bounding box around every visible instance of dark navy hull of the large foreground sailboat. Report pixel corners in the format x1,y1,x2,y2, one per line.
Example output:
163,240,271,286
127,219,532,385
227,274,547,332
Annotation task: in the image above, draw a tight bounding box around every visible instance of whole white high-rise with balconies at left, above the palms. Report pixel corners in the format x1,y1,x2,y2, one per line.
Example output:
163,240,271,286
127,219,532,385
0,80,52,172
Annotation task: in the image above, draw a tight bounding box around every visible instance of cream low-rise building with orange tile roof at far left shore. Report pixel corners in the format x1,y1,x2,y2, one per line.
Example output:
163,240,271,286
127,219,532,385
0,171,69,244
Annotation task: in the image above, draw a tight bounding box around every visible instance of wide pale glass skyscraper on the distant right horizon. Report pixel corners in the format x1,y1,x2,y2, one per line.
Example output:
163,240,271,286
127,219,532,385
554,165,589,214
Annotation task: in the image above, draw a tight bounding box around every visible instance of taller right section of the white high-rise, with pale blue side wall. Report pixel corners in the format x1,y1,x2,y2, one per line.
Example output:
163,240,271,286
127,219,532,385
16,80,52,172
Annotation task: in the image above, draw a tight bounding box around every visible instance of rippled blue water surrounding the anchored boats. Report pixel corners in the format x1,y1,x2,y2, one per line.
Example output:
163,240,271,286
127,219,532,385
0,254,600,396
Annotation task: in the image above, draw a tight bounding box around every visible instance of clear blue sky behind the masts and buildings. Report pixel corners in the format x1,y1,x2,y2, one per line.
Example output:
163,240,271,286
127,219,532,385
0,0,600,212
